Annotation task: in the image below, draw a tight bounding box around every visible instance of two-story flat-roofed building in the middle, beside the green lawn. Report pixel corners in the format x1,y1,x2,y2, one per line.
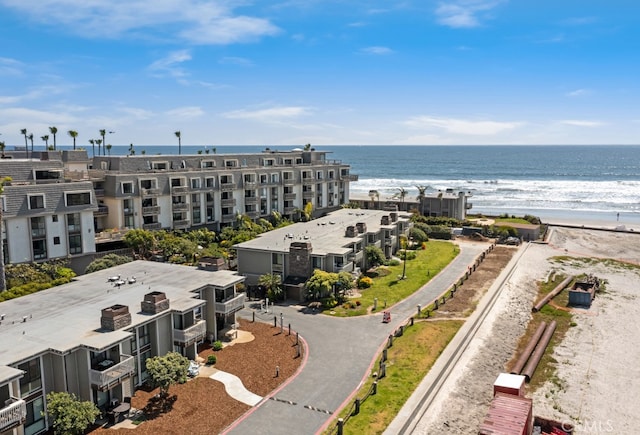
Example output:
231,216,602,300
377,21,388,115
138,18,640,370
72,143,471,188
234,209,411,300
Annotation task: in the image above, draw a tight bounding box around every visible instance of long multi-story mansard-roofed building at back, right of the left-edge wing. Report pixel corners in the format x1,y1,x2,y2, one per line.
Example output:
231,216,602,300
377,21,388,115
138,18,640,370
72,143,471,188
94,150,357,238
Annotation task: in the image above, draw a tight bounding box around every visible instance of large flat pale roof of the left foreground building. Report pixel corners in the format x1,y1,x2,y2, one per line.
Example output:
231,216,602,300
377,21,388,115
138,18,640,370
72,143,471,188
0,260,244,366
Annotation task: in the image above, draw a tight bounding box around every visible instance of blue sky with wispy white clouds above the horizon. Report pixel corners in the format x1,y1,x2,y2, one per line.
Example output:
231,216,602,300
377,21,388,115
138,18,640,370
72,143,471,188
0,0,640,146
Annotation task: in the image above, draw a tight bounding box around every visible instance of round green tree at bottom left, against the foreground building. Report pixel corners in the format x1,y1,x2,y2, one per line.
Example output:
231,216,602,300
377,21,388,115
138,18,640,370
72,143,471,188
43,391,100,435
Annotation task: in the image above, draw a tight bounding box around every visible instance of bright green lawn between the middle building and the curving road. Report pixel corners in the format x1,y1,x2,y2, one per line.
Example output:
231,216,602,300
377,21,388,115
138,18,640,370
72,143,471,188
325,240,460,317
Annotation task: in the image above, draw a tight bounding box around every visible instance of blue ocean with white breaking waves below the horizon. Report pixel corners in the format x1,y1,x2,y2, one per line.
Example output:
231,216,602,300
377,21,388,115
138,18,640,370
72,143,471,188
52,145,640,229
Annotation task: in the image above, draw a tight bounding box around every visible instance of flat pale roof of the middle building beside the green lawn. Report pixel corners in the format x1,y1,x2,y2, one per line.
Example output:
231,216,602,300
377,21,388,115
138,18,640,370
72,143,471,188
235,208,410,255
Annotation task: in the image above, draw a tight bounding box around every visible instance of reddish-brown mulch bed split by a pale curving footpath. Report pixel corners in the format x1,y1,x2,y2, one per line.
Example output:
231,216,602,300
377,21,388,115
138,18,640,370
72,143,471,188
92,320,303,435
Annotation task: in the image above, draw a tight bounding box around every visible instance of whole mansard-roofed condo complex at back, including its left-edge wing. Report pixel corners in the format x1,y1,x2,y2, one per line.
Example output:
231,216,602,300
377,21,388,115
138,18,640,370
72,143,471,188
0,149,357,263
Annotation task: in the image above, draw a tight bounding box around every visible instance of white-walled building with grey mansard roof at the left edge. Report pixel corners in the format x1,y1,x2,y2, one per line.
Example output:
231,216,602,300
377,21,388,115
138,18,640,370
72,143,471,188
0,152,97,263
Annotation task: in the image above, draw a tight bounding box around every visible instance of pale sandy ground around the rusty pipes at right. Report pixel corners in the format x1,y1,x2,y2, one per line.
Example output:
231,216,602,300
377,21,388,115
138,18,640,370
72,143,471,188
415,225,640,434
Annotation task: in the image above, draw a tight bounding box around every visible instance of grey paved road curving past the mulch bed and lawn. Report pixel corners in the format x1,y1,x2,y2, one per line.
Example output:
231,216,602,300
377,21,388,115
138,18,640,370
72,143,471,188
228,242,488,435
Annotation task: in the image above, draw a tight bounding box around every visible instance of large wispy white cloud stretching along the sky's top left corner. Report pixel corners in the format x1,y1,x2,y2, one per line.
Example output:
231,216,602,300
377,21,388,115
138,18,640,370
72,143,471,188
3,0,279,44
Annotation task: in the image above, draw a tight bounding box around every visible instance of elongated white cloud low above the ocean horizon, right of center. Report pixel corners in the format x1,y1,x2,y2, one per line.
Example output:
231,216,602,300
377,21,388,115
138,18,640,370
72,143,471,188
404,116,522,136
